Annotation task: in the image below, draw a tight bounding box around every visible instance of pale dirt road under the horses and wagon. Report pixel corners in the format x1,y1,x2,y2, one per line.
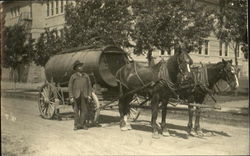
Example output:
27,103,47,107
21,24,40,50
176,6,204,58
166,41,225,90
1,98,249,155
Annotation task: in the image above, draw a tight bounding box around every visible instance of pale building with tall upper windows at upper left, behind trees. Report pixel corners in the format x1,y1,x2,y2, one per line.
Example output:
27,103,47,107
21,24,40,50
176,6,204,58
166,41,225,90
2,0,70,82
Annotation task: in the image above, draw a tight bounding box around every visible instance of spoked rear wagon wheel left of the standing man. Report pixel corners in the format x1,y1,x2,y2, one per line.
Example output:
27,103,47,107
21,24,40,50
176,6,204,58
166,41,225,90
38,84,55,119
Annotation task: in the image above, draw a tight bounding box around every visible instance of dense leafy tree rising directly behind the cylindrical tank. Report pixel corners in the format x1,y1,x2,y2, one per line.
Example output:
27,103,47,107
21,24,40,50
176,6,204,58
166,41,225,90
65,0,135,47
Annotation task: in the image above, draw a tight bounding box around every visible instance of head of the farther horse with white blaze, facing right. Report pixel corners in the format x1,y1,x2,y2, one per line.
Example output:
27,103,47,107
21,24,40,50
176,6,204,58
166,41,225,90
219,59,239,90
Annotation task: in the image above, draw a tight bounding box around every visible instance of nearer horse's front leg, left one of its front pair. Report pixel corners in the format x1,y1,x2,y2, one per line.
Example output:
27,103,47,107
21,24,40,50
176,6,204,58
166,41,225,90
151,94,160,139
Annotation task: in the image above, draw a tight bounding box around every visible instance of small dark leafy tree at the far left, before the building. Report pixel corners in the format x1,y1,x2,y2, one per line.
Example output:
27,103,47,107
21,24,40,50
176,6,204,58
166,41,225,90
3,25,34,81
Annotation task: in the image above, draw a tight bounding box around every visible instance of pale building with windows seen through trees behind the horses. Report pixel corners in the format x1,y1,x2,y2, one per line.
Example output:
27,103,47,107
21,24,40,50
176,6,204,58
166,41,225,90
132,0,248,77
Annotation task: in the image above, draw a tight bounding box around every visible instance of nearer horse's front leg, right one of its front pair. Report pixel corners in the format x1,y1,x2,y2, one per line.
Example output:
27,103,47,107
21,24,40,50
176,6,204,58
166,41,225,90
161,100,170,137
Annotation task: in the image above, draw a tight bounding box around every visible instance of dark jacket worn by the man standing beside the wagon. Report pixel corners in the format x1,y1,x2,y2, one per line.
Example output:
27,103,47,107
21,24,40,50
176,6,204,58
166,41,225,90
69,72,92,98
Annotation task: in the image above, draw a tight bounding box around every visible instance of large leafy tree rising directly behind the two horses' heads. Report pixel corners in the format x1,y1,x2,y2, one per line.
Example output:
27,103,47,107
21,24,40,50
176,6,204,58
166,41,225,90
132,0,214,62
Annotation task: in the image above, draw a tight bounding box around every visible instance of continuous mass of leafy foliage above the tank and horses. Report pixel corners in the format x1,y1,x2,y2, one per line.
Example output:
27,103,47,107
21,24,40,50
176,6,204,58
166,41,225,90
36,0,218,65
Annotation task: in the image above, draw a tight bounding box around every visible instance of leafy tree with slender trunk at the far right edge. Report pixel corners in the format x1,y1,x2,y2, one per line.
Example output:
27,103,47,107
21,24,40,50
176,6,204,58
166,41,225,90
216,0,248,65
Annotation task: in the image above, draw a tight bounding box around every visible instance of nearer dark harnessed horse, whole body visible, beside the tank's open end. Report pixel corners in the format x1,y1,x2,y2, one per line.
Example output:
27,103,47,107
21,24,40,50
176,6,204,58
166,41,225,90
116,52,193,138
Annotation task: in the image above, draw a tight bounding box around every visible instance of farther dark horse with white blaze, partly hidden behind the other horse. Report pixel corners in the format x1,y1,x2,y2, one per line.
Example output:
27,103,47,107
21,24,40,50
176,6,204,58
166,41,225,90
176,59,239,136
